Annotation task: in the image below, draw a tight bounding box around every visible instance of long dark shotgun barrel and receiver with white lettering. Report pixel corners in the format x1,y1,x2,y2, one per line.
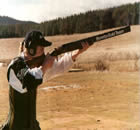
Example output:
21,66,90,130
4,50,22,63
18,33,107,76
50,26,131,56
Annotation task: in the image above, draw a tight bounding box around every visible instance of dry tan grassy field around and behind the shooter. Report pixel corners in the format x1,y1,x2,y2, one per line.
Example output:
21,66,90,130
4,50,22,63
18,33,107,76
0,26,140,130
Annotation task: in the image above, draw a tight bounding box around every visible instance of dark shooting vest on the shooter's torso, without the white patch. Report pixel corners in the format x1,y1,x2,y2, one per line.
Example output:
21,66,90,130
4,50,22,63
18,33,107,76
0,58,40,130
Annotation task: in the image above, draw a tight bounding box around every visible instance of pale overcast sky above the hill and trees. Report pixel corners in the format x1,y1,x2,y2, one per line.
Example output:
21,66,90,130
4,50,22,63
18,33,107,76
0,0,140,23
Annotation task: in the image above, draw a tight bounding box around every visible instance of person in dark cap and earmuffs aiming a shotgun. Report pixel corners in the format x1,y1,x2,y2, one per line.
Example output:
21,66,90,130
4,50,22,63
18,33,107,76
0,31,88,130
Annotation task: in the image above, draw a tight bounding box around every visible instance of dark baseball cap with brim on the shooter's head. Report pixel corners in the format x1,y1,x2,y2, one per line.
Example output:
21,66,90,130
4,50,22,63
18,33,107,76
24,30,52,48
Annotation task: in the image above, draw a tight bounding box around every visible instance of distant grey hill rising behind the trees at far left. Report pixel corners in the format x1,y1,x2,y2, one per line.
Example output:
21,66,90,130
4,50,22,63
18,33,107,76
0,16,37,25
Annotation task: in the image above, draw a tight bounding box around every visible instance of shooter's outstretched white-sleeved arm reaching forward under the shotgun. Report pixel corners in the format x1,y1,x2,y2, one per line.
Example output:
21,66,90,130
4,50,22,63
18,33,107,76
41,43,89,79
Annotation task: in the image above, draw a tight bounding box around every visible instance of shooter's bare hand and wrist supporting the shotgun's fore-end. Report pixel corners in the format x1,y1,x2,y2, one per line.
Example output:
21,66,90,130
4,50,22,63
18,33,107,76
72,42,89,61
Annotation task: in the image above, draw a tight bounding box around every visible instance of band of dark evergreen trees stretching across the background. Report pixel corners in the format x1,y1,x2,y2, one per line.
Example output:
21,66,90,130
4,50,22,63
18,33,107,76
0,2,140,38
